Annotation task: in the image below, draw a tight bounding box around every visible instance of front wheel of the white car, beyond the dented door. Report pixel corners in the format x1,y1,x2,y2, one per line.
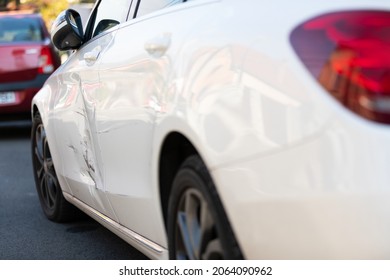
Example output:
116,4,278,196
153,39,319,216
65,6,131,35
31,113,79,222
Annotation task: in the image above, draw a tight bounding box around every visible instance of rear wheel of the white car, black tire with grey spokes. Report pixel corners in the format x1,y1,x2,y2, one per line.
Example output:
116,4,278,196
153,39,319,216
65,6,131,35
168,156,243,259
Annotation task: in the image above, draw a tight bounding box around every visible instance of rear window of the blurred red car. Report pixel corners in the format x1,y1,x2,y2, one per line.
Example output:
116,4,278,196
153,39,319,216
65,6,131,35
0,17,44,43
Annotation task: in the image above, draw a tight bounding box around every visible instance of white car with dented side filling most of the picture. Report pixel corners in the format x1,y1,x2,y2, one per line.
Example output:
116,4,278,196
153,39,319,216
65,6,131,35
32,0,390,259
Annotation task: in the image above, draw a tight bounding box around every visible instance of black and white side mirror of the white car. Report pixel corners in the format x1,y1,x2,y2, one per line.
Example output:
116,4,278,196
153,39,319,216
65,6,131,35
51,9,84,51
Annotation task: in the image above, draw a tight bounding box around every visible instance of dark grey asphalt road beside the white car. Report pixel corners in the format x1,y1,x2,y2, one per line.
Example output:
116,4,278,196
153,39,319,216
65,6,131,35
0,122,146,260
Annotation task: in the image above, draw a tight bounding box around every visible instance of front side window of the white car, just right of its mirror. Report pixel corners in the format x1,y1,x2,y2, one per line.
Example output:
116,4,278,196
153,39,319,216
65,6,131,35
92,0,131,37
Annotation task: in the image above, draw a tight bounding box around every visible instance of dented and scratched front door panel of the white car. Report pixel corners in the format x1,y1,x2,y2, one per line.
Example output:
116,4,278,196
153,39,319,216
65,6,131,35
51,33,115,219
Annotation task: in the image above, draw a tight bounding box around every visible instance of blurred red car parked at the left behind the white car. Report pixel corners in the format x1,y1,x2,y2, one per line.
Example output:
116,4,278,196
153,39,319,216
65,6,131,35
0,12,60,120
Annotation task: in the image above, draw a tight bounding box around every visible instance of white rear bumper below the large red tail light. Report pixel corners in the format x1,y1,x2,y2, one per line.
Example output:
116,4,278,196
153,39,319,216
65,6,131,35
212,115,390,259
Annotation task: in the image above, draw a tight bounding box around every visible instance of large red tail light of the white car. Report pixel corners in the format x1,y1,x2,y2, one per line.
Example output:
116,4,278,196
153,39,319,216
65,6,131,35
290,11,390,124
